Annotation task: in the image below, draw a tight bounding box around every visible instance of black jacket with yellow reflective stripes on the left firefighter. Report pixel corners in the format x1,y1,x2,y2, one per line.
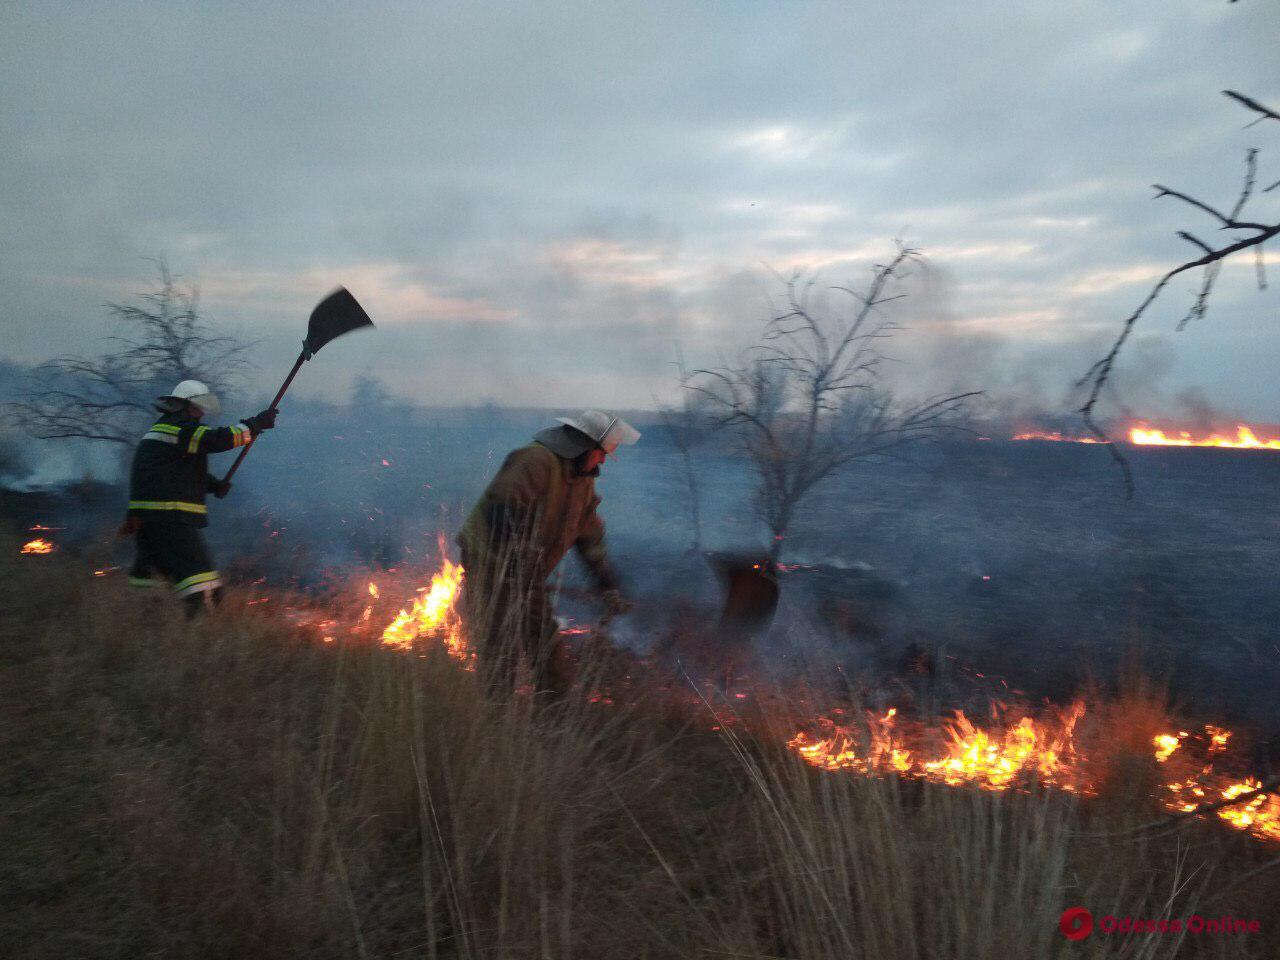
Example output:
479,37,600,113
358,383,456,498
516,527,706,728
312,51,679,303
129,413,255,526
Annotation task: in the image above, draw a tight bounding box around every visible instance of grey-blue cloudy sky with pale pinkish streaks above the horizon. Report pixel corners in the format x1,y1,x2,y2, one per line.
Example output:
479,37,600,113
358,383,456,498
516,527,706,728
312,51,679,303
0,0,1280,421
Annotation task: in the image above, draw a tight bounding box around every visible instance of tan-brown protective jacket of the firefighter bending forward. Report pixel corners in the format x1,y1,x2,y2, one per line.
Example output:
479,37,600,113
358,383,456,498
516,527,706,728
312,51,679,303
458,440,617,589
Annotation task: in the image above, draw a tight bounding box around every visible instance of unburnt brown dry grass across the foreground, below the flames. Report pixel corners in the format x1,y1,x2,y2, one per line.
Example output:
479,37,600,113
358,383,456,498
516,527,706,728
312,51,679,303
0,529,1280,960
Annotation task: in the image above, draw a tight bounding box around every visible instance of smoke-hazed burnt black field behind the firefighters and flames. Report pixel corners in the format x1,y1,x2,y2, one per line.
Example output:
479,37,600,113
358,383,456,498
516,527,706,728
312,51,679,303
4,408,1280,732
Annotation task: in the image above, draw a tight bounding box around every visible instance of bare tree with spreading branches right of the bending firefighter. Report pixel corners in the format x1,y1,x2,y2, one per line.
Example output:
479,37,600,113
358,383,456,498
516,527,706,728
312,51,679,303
690,246,978,561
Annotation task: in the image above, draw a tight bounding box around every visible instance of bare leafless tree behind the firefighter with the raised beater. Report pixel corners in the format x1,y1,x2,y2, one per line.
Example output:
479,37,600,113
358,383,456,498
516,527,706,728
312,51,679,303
8,261,251,444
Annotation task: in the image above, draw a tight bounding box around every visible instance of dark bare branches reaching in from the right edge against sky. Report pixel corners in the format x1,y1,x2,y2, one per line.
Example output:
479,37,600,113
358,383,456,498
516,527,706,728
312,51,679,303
1076,90,1280,497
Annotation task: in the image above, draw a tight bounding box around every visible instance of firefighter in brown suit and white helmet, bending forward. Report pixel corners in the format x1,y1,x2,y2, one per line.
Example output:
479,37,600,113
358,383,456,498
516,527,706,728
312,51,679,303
458,410,640,694
